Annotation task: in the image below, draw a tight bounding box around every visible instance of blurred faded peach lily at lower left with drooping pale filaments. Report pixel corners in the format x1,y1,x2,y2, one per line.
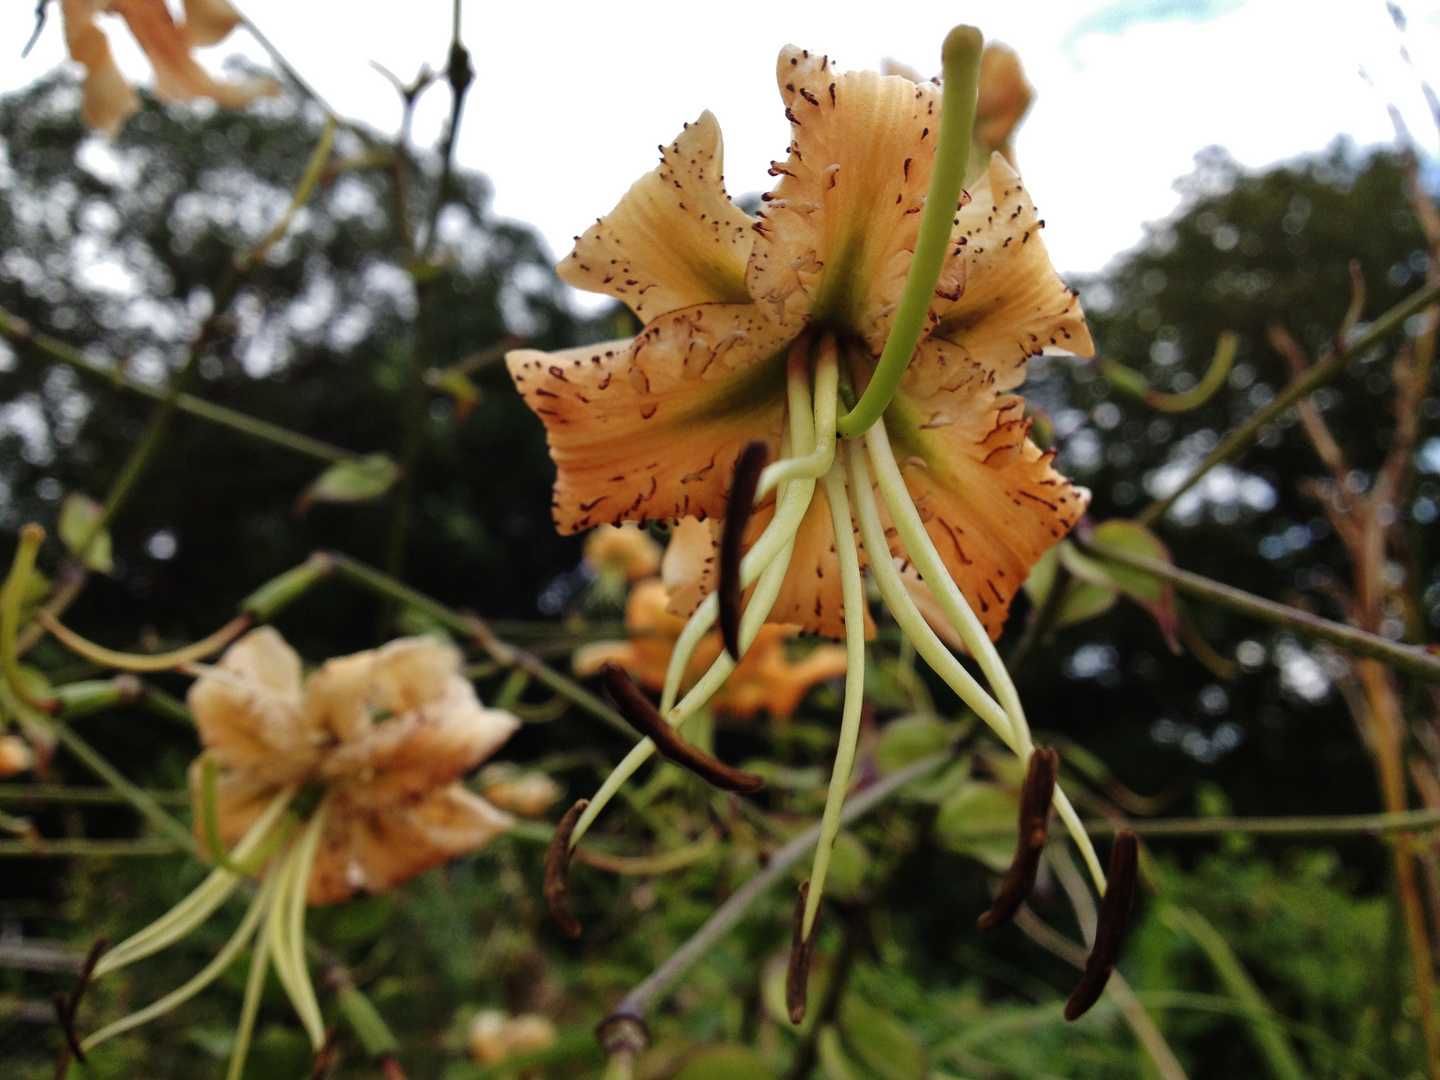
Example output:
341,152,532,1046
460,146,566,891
82,626,518,1079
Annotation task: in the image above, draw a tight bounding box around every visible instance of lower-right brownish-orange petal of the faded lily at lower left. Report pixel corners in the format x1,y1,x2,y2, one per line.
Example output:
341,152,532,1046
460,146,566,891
305,783,513,906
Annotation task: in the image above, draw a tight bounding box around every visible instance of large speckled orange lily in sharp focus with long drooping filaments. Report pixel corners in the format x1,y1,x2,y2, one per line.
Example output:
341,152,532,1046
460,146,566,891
507,27,1103,1008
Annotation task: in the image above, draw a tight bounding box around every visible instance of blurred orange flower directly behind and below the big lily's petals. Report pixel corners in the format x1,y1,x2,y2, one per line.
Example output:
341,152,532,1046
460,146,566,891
575,577,845,720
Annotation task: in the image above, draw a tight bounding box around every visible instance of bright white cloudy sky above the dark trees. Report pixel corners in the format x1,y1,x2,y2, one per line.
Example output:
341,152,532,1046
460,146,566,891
0,0,1440,296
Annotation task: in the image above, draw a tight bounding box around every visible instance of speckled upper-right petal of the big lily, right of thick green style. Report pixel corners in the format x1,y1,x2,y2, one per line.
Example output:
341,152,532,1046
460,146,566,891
933,154,1094,377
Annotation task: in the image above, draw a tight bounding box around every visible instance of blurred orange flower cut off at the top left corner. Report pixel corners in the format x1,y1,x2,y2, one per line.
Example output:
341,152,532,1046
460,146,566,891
60,0,278,135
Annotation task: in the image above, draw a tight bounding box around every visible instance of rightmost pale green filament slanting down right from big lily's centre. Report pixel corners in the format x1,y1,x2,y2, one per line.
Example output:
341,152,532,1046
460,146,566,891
865,420,1031,757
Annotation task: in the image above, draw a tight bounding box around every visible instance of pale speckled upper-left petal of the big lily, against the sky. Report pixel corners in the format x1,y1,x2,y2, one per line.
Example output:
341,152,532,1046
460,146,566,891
556,111,755,320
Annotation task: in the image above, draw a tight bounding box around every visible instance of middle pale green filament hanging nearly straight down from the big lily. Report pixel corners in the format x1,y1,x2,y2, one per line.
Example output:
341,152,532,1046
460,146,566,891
801,462,865,940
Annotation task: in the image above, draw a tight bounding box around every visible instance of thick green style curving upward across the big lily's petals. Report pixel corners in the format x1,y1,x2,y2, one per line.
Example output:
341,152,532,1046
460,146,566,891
840,26,985,436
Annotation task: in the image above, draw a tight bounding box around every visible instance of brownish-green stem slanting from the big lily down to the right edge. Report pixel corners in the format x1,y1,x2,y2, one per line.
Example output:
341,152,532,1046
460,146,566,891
1076,539,1440,683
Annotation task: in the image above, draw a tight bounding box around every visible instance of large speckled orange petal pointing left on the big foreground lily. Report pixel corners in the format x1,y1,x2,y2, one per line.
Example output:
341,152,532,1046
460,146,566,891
505,304,789,533
